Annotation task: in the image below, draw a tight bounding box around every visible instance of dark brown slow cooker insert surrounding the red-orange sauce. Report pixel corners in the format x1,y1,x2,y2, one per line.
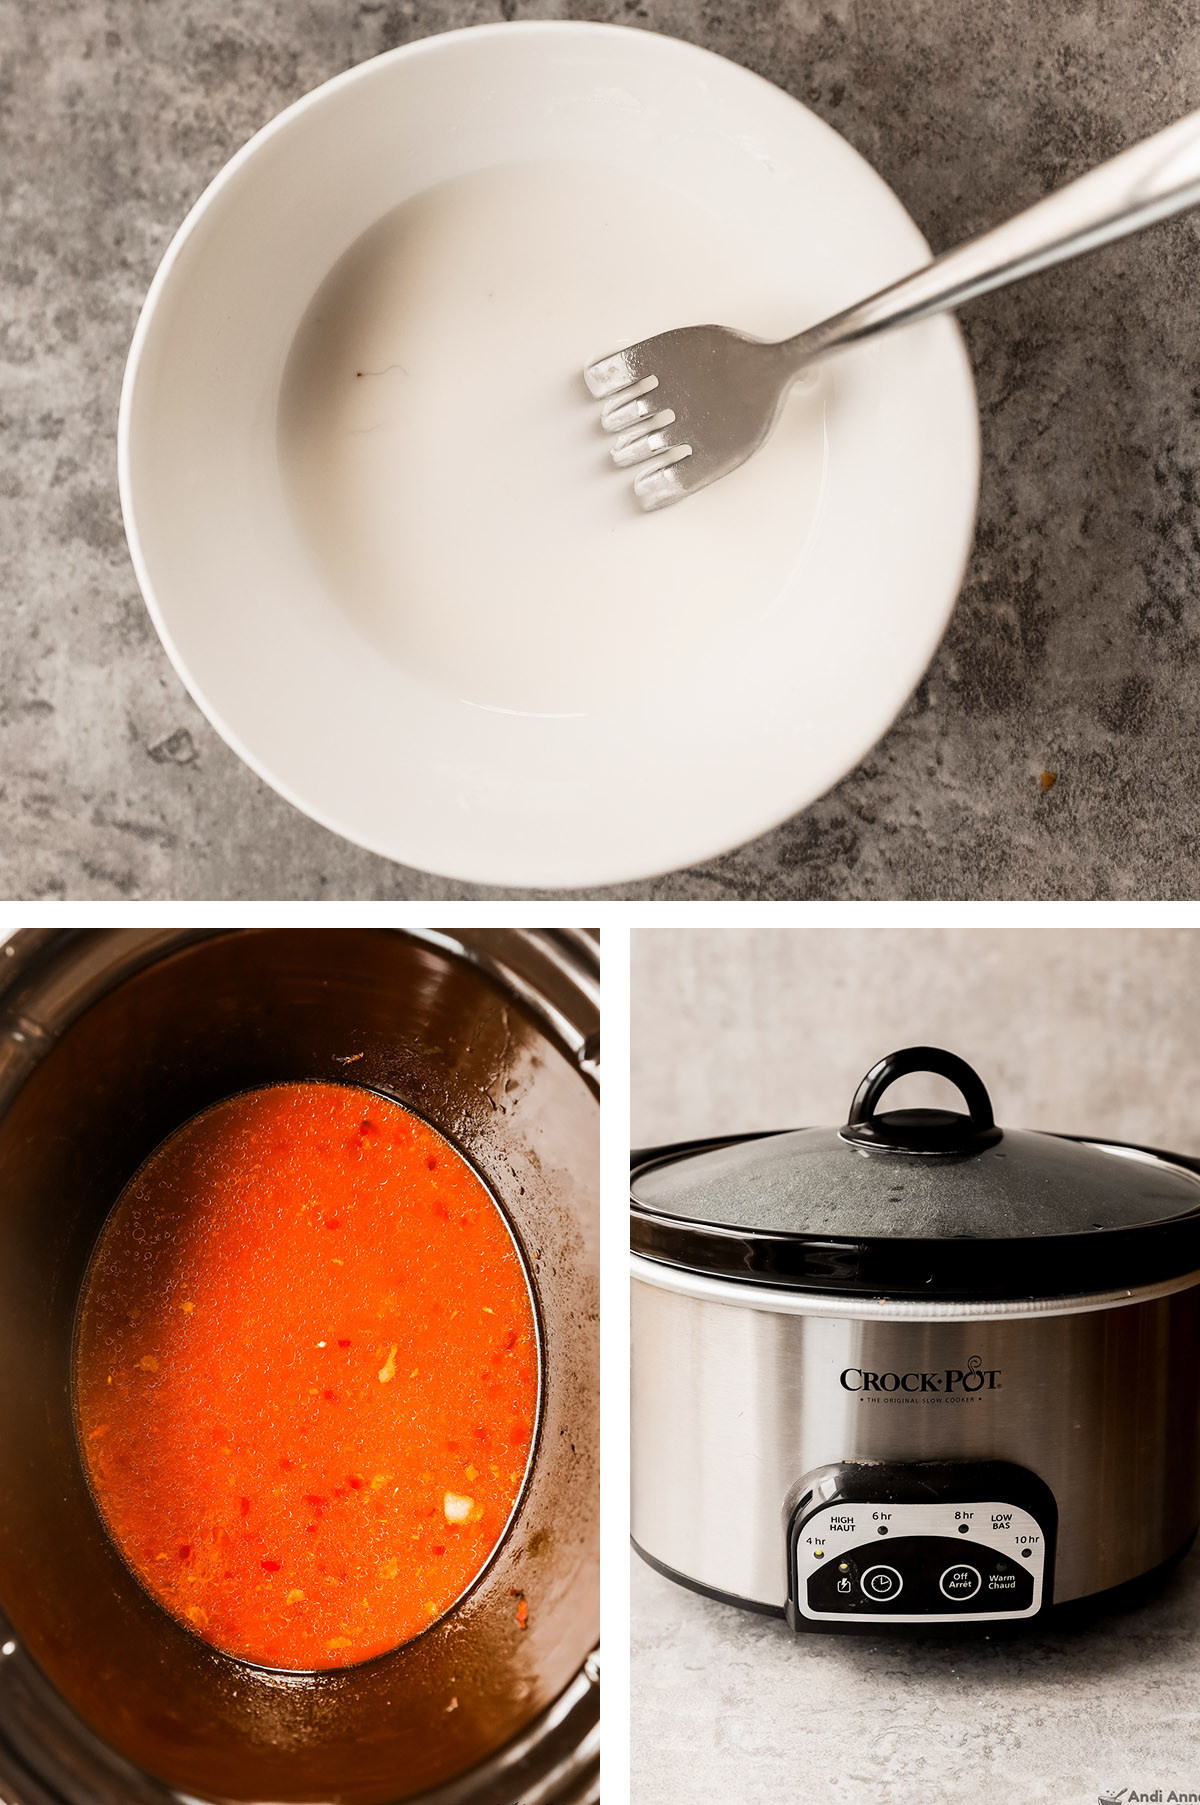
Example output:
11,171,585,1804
0,930,599,1805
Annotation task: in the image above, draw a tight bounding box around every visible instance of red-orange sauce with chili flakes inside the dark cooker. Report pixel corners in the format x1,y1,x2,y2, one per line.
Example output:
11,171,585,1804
76,1083,538,1670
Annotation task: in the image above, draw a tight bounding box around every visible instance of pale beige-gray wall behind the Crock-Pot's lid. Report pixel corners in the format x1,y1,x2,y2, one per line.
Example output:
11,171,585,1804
630,928,1200,1153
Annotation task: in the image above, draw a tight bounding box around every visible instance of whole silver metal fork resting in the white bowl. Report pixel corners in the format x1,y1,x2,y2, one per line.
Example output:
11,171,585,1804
583,112,1200,509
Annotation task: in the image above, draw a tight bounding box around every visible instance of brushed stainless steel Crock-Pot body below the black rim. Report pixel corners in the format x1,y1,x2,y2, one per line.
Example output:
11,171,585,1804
632,1251,1200,1628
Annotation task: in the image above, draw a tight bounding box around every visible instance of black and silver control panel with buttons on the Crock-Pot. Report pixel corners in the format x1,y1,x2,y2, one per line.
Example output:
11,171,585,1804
789,1460,1057,1628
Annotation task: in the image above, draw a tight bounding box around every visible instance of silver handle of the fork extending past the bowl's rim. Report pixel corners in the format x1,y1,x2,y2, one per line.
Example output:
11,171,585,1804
780,112,1200,374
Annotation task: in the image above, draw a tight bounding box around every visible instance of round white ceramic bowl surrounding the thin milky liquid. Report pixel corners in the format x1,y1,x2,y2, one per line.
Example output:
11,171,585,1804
119,23,978,888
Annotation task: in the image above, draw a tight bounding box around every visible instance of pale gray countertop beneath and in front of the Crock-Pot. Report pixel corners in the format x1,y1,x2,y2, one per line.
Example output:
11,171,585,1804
630,1552,1200,1805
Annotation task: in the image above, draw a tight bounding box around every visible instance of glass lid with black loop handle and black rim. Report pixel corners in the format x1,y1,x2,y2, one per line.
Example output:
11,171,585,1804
632,1047,1200,1298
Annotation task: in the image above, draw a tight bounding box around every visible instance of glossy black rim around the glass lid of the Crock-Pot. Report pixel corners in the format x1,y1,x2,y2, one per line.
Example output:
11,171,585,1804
630,1135,1200,1303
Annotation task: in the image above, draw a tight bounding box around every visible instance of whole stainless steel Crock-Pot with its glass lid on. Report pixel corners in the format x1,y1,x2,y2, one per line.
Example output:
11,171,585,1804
632,1047,1200,1634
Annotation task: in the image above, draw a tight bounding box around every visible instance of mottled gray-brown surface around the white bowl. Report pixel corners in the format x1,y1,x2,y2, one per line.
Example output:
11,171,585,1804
0,0,1200,899
